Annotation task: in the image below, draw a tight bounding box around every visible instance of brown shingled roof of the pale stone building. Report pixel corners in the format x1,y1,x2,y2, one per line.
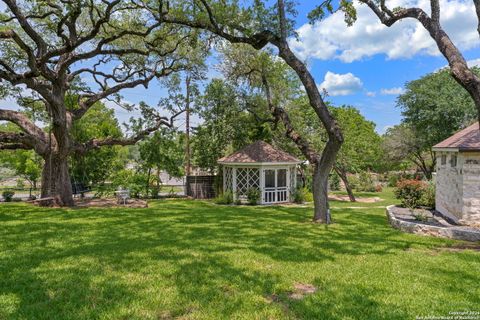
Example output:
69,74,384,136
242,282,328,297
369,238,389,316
433,122,480,151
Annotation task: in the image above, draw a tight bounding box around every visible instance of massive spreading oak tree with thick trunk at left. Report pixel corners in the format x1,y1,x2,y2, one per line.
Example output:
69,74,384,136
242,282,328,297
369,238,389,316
0,0,194,205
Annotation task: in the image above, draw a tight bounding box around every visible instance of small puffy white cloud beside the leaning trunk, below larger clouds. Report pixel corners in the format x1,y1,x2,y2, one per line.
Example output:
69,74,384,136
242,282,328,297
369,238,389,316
319,71,363,96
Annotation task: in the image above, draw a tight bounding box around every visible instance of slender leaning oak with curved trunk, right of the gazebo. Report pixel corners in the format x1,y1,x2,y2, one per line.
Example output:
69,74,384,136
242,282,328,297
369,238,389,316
144,0,343,223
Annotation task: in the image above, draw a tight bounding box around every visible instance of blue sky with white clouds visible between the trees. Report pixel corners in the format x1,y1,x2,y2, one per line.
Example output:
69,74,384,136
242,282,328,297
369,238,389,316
0,0,480,133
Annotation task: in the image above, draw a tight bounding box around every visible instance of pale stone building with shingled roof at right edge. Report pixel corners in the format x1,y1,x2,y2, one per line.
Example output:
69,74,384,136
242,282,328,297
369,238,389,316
433,122,480,225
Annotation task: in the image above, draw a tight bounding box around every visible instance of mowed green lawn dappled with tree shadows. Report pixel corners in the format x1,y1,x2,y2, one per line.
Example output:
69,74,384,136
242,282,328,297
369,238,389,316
0,192,480,320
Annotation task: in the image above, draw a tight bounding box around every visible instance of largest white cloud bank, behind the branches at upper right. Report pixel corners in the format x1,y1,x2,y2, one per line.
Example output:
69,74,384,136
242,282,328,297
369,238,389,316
290,0,480,62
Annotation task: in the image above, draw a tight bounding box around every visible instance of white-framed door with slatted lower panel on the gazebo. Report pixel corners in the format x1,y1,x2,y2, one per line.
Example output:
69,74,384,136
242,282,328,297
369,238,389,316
263,169,288,203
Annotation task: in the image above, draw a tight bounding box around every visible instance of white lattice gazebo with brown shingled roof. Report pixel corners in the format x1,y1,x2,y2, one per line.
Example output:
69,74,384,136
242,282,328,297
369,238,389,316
218,141,302,204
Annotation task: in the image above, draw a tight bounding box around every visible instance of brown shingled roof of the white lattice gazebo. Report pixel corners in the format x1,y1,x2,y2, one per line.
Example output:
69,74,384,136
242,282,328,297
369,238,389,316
218,141,301,164
